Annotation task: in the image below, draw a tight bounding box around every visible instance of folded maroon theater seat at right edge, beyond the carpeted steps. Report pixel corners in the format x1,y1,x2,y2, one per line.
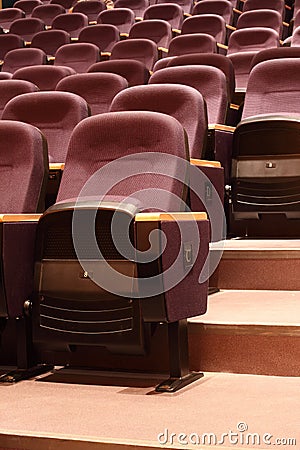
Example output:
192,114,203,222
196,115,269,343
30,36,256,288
231,58,300,237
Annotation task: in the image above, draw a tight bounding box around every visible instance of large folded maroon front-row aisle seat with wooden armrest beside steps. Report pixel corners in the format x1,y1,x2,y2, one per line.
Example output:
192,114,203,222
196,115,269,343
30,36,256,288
18,111,209,392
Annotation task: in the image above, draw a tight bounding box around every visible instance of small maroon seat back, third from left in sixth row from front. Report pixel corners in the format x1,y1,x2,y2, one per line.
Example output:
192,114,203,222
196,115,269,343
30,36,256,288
78,24,120,52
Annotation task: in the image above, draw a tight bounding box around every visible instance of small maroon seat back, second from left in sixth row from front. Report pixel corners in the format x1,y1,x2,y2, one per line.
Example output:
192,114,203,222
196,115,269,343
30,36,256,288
31,30,71,56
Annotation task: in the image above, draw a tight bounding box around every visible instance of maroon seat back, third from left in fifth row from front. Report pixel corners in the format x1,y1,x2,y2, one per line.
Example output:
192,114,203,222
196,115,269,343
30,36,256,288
110,39,158,70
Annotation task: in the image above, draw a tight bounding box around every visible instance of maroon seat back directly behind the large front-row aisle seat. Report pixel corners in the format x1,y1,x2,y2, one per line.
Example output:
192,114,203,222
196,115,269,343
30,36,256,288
111,84,207,159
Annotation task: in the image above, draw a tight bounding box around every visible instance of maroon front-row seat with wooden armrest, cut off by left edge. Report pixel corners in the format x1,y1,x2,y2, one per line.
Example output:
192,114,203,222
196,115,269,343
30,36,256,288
0,120,48,372
